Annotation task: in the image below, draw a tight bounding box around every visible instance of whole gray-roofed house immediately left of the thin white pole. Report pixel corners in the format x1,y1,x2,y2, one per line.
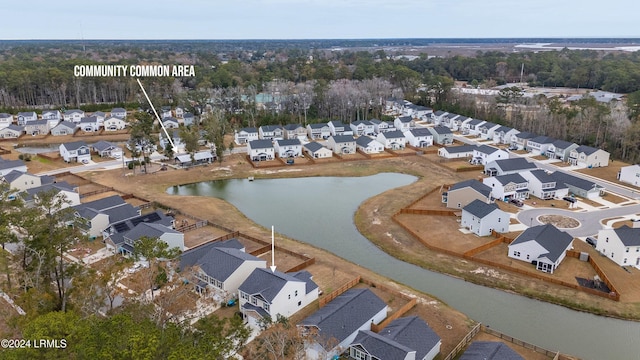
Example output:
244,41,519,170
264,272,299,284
180,239,267,301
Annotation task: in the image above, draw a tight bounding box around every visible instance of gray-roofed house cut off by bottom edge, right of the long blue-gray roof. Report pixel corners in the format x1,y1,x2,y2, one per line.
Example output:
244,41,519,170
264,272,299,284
349,316,442,360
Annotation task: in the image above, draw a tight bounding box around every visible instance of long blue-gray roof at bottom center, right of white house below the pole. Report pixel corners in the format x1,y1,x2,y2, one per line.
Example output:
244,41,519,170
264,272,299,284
299,289,387,342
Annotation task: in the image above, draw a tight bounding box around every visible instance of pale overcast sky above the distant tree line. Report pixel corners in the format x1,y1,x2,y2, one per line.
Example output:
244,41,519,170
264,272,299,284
0,0,640,40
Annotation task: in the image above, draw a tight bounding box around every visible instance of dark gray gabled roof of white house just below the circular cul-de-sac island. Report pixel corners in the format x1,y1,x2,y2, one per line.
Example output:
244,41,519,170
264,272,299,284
510,224,573,262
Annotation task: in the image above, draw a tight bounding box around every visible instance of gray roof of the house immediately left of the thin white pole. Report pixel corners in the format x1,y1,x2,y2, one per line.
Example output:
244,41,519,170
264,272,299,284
180,240,266,281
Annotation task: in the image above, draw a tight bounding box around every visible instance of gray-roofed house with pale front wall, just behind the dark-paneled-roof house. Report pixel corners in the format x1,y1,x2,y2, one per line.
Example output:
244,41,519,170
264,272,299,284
73,195,140,239
